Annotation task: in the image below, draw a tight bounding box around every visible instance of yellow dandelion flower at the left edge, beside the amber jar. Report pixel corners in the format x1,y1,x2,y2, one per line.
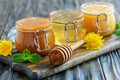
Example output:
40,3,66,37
0,39,13,56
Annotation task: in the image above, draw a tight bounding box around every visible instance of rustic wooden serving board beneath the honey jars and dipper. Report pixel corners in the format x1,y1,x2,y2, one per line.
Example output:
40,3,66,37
3,35,120,79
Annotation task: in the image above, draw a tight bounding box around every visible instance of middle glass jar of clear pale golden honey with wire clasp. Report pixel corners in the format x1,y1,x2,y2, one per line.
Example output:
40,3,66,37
50,10,86,45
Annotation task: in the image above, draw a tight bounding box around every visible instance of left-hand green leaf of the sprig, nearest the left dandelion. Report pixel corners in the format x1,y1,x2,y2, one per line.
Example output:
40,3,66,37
12,53,27,62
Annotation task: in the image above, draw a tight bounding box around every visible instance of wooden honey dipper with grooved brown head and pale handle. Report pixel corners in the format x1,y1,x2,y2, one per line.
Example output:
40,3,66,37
49,40,84,66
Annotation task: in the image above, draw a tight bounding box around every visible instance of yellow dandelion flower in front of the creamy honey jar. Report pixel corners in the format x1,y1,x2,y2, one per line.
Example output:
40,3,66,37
85,32,104,50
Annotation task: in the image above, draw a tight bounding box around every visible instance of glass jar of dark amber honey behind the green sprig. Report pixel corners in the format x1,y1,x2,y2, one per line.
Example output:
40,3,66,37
15,17,55,55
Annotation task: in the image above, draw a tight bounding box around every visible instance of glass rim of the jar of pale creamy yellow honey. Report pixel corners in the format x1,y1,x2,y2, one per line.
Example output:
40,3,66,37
81,2,114,15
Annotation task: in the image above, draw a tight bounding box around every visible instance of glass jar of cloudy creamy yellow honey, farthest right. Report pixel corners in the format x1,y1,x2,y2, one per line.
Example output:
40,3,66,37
81,2,116,36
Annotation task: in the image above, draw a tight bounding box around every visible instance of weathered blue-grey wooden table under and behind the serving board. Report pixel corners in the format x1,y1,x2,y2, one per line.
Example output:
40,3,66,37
0,0,120,80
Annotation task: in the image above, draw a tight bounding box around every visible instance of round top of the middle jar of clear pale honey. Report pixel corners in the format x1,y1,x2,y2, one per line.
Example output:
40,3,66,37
50,9,83,23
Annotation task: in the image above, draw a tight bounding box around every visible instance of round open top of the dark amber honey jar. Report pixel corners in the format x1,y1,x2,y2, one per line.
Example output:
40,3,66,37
16,17,51,32
